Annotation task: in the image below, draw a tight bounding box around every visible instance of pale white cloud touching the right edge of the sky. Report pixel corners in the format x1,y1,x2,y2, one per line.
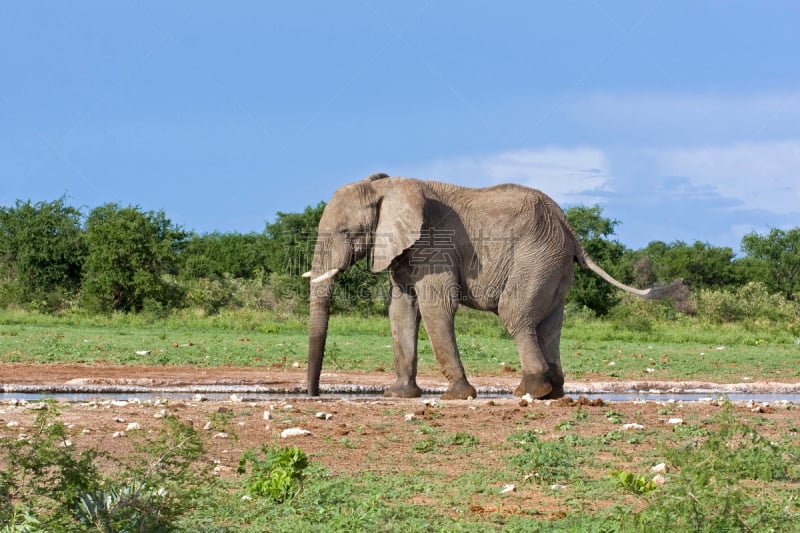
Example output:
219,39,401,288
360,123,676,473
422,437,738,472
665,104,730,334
652,140,800,215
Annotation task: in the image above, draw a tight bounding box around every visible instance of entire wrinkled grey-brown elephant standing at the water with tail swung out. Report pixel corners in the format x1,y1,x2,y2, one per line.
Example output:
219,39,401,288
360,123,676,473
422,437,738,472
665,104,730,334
306,174,668,399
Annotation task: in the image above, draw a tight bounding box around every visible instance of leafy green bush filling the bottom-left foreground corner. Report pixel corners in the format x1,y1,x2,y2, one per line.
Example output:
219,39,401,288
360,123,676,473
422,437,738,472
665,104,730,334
0,401,213,533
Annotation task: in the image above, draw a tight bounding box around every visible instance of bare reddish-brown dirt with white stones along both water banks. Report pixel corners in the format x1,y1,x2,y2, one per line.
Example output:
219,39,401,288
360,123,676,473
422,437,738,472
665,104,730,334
0,364,797,519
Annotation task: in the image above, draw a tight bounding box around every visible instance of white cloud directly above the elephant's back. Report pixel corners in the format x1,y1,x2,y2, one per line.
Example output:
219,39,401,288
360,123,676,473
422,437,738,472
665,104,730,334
404,147,611,204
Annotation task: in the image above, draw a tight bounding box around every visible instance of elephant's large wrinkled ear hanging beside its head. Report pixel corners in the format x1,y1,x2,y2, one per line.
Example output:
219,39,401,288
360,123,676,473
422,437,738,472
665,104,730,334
372,178,425,272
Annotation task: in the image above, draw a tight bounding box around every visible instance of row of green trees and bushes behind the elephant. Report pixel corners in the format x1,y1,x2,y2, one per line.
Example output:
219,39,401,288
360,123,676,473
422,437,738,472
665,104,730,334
0,198,800,315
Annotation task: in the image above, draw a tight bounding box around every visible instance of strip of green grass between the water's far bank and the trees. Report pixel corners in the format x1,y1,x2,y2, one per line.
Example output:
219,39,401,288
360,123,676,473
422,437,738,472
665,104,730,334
0,304,800,382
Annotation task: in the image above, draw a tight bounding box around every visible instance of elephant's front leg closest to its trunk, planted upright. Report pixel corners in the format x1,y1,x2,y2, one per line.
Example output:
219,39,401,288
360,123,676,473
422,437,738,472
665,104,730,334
383,285,422,398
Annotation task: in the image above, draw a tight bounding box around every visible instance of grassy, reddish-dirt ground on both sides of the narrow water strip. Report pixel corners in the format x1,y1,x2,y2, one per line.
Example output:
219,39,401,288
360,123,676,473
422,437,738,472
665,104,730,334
0,308,800,532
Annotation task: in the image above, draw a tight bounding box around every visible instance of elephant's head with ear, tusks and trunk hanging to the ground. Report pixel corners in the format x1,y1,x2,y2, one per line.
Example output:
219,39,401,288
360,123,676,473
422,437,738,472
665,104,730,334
305,174,425,396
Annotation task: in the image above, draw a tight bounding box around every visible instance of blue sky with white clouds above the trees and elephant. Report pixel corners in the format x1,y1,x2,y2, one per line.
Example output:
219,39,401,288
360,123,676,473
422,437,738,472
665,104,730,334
0,0,800,251
